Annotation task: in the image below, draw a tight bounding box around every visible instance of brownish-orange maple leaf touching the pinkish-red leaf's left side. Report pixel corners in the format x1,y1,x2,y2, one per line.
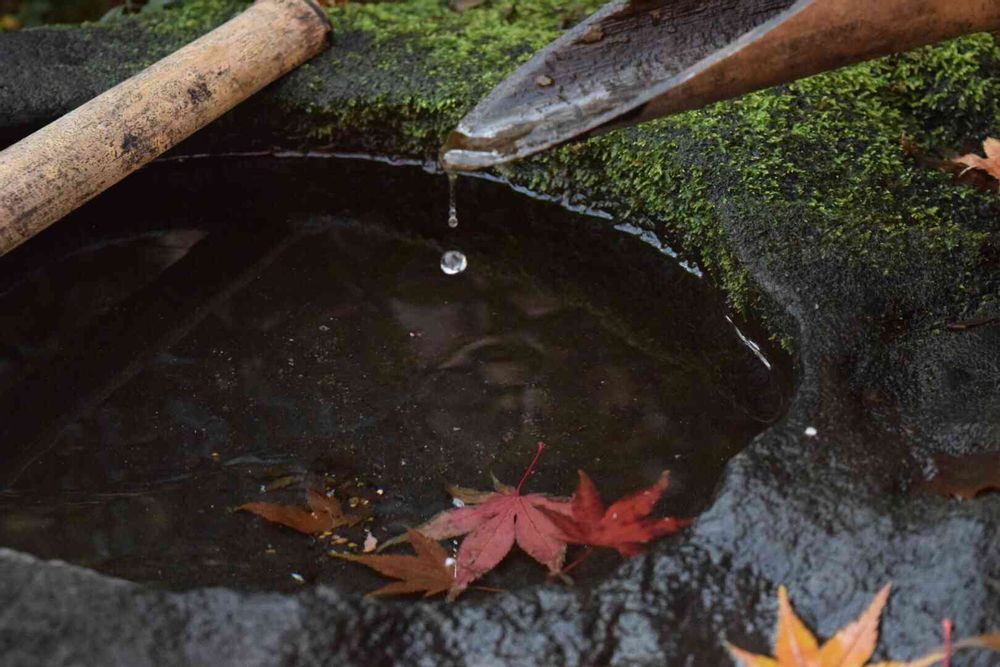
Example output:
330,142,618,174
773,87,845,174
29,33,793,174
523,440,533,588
330,530,455,597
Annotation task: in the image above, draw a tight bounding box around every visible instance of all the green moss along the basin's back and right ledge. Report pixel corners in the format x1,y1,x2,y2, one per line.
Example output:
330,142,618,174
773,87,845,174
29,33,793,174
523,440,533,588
0,0,1000,352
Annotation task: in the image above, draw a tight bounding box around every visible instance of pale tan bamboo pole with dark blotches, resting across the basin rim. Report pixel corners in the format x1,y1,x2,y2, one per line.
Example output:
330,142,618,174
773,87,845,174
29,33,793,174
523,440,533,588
0,0,330,255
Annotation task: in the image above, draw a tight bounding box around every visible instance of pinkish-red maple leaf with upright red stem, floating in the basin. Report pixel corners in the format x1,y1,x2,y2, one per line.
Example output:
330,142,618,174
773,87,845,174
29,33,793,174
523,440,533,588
417,442,569,598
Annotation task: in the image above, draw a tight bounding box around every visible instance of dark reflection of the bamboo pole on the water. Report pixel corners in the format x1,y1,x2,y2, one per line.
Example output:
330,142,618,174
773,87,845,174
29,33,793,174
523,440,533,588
0,228,301,489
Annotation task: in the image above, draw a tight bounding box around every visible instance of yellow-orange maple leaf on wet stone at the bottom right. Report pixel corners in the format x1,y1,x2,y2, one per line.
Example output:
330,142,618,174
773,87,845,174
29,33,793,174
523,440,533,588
726,586,1000,667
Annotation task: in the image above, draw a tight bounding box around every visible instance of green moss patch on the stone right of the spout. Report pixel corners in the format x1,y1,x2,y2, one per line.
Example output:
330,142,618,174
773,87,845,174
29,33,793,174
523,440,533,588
510,35,1000,334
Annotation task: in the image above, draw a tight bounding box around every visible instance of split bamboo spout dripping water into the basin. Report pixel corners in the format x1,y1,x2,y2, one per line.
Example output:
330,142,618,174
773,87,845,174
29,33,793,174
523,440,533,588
441,0,1000,171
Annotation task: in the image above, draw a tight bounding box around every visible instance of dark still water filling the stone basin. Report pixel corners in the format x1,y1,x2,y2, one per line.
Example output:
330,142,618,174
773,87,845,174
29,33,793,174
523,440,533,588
0,158,792,595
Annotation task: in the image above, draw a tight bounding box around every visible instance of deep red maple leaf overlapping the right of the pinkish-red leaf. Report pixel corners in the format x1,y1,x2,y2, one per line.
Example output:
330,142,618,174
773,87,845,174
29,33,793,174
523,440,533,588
548,470,692,556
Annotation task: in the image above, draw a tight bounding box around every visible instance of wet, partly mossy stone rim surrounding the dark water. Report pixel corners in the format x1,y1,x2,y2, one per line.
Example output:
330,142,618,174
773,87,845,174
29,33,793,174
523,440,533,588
0,0,1000,665
